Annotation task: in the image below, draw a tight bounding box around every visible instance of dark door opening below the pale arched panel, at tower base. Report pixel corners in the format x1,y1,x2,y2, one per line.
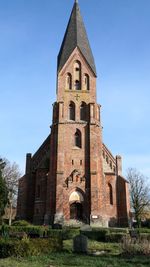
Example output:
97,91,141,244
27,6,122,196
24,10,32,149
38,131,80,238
70,202,83,220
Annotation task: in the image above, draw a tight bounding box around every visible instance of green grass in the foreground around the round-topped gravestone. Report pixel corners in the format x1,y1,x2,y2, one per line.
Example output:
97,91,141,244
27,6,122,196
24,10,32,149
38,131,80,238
0,240,150,267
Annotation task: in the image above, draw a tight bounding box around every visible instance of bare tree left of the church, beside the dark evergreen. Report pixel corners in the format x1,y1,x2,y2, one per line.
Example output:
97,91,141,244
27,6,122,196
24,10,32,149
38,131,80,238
2,159,21,225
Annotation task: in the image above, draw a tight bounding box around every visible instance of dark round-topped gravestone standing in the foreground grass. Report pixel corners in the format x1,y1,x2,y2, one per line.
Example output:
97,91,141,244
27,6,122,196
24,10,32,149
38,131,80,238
73,235,88,253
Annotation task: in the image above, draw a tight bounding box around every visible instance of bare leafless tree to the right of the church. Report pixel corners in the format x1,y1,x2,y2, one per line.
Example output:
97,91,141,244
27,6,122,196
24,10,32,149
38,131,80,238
127,168,150,227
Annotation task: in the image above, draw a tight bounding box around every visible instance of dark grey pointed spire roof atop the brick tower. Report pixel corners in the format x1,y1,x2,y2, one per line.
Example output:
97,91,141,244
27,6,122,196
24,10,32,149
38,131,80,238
57,1,96,75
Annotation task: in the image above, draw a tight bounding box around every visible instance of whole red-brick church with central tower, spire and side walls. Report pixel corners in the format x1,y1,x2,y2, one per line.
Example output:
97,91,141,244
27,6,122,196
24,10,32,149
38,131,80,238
17,1,129,226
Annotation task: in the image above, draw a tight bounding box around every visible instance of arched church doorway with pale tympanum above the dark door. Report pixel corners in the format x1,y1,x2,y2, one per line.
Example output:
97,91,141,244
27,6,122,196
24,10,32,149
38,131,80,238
69,191,84,220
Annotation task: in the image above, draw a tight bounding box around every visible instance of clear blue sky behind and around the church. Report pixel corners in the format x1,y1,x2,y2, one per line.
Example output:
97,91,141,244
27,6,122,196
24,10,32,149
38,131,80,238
0,0,150,180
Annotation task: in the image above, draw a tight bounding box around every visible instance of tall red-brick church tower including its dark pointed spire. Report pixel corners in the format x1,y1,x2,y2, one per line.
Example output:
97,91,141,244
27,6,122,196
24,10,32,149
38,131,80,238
47,1,105,225
